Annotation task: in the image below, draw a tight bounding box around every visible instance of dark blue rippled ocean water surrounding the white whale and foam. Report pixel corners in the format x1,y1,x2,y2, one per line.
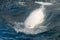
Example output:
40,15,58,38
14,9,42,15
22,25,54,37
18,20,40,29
0,0,60,40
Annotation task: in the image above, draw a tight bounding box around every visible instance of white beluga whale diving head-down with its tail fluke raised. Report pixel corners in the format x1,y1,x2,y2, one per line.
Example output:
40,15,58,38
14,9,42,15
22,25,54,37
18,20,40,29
24,1,52,28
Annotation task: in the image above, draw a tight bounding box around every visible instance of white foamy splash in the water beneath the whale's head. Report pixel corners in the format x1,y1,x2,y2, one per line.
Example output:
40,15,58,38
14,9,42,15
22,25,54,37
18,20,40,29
13,22,47,34
